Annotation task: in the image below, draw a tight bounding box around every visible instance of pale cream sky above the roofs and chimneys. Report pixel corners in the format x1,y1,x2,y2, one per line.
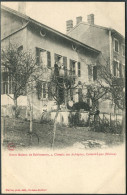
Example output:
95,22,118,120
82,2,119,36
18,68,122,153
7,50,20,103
2,2,125,35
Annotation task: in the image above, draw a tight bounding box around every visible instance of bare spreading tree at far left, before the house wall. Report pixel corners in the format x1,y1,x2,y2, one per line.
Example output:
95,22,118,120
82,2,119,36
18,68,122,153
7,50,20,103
1,44,39,126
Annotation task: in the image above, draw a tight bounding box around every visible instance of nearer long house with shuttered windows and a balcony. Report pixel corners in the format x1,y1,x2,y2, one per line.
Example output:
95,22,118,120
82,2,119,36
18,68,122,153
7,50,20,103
1,2,100,118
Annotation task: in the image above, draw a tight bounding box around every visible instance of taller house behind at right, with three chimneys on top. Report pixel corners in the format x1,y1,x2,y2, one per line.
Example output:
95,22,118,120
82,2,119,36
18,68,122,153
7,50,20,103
66,14,125,112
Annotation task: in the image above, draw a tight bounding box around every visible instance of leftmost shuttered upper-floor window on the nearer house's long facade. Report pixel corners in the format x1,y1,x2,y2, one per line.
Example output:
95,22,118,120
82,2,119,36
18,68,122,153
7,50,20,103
36,48,51,68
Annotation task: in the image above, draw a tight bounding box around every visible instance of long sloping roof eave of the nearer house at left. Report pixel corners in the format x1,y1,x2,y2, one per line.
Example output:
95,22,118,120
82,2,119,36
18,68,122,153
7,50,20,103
1,5,100,53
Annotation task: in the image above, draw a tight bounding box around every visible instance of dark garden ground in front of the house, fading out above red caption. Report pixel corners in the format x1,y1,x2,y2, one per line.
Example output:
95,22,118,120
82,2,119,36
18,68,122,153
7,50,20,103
3,118,124,149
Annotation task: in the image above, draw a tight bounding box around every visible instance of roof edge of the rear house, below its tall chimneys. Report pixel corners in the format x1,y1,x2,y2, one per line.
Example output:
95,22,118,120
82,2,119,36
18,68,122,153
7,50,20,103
67,22,125,39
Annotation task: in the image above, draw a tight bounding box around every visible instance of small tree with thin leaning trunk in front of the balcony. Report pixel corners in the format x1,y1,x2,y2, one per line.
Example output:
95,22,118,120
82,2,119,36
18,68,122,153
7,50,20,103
41,64,78,148
